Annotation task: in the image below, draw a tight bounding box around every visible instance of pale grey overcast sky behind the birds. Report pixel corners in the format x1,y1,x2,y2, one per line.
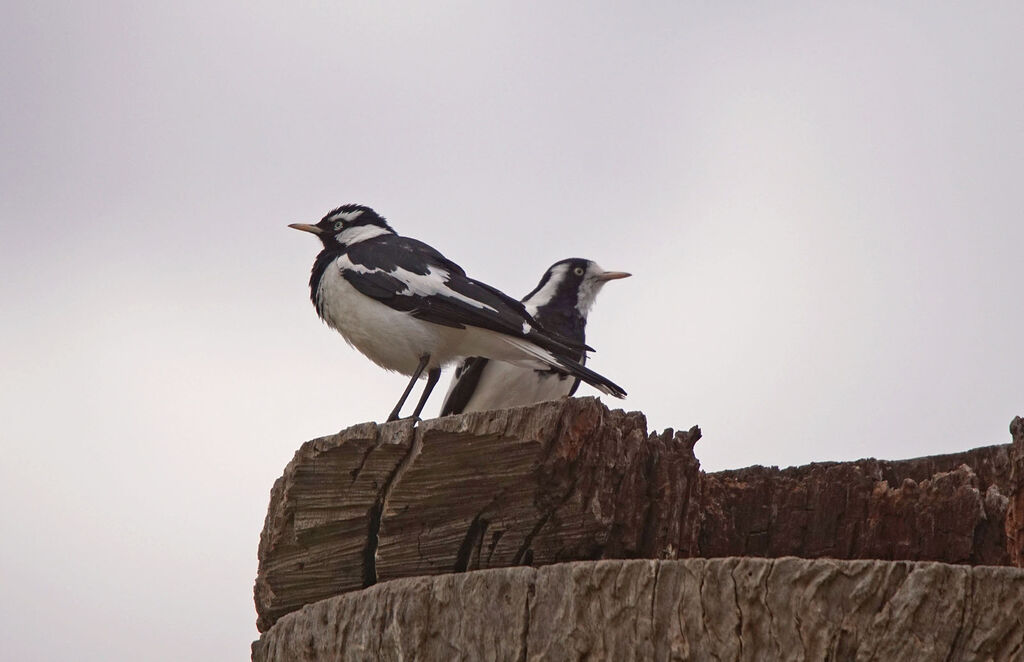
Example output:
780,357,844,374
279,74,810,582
0,0,1024,661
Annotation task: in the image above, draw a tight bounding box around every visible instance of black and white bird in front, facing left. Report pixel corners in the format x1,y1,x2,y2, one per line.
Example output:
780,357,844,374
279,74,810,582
289,205,626,420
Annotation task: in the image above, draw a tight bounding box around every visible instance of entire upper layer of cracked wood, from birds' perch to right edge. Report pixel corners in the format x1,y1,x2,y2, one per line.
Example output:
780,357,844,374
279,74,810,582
255,398,1024,631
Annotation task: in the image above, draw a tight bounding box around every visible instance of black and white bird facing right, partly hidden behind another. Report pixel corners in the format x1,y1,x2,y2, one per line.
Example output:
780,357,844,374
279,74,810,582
441,257,630,416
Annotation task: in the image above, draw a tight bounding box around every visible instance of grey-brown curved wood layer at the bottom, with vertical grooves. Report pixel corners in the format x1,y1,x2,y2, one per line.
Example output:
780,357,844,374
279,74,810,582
253,557,1024,662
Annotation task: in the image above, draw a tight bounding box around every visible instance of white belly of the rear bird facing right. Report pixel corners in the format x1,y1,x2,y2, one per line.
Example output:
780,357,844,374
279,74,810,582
463,361,575,412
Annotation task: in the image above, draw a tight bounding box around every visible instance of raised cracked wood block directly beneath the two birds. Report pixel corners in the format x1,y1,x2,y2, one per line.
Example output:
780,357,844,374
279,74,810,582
255,398,699,630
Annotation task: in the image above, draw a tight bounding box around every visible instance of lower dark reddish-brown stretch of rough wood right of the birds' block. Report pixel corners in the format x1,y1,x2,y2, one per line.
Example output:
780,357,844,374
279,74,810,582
695,446,1011,565
